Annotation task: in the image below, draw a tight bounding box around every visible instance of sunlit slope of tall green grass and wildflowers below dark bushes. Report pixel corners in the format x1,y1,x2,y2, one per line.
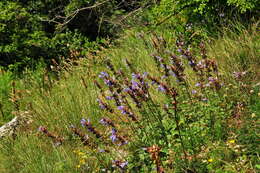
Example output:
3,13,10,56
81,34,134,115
0,23,259,172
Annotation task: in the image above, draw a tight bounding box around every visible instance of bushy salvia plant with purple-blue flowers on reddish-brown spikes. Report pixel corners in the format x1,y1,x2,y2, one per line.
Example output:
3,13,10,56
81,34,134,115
36,34,250,173
